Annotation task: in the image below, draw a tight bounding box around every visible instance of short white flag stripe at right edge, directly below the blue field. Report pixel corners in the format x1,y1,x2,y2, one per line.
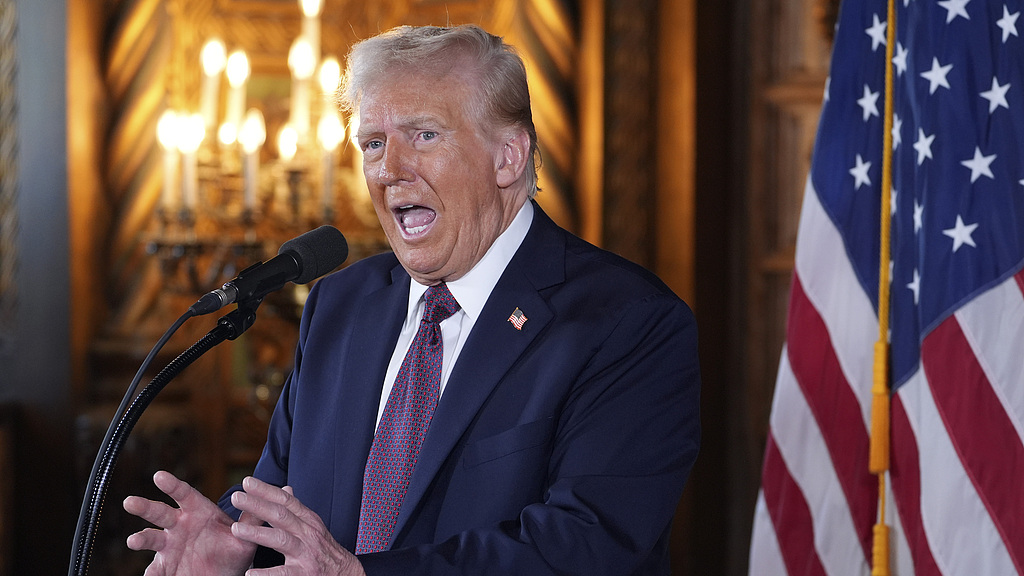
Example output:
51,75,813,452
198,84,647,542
955,277,1024,438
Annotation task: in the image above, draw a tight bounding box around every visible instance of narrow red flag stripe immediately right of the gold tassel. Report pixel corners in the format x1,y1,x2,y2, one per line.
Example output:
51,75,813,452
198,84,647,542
889,395,942,576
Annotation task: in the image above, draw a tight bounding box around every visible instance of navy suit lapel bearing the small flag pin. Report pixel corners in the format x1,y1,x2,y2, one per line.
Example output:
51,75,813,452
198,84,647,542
391,205,565,543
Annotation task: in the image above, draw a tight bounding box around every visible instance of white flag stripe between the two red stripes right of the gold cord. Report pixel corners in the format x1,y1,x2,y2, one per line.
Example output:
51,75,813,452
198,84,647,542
894,370,1016,576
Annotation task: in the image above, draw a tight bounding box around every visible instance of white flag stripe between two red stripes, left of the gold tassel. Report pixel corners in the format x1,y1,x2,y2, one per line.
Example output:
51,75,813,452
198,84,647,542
770,353,867,576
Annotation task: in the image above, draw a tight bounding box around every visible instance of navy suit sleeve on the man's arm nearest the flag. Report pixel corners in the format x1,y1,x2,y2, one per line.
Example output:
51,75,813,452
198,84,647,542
360,294,700,576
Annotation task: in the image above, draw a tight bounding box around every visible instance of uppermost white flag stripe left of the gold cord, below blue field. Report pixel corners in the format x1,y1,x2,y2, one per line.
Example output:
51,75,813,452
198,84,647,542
796,178,879,429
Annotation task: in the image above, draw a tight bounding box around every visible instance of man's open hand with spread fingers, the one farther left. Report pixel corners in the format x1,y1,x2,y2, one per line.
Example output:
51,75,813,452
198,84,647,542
124,470,259,576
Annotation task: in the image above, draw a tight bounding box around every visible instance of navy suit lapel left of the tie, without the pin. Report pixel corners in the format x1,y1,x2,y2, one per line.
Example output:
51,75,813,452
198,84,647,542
325,266,410,549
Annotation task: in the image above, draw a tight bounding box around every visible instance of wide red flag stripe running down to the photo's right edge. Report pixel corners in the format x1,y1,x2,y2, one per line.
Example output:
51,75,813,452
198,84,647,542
921,317,1024,573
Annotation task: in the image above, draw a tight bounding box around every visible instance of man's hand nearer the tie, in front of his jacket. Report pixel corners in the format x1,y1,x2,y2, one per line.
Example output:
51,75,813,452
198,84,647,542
231,477,366,576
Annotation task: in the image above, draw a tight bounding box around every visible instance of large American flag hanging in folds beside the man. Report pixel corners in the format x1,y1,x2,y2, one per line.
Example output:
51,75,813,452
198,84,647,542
750,0,1024,576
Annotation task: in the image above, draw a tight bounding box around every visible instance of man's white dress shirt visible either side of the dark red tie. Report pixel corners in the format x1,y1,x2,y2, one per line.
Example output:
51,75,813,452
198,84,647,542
377,201,534,424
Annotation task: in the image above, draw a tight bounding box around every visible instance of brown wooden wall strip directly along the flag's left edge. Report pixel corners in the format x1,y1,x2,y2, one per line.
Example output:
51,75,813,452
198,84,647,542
741,0,838,492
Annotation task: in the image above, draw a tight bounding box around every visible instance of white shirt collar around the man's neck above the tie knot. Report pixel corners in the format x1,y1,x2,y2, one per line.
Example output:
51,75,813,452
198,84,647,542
408,201,534,321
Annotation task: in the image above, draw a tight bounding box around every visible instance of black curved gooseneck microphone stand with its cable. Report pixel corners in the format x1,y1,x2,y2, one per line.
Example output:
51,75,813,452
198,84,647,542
68,297,263,576
